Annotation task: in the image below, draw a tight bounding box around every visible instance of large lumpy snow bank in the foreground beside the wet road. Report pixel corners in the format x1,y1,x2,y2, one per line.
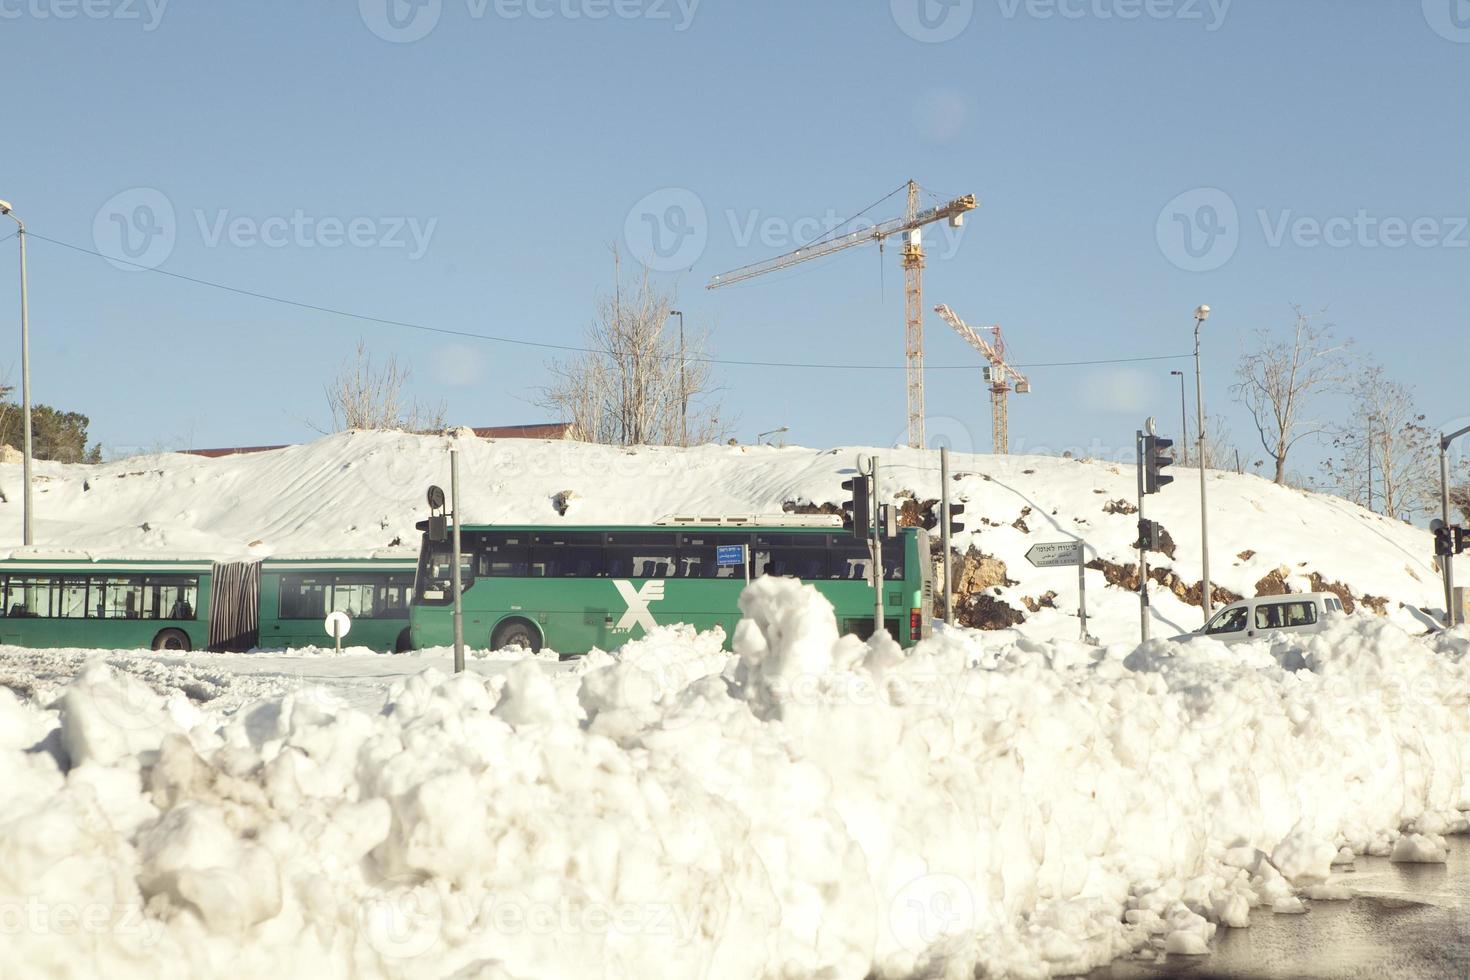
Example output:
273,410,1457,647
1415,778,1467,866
0,579,1470,980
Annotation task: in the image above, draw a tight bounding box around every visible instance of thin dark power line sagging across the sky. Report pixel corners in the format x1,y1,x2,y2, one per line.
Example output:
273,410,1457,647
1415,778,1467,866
26,231,1192,370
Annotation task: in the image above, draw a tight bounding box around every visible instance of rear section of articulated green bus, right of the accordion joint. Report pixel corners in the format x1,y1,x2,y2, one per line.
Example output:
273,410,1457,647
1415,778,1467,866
256,557,417,652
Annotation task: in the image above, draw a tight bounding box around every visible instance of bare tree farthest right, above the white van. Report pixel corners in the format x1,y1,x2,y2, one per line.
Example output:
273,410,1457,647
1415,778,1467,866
1322,364,1439,520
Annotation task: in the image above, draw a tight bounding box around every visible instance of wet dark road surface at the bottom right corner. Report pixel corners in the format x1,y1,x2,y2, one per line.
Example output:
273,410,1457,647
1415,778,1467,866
1089,837,1470,980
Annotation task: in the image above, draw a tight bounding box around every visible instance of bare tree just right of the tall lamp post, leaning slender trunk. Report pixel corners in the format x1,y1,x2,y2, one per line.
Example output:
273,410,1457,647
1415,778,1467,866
1232,306,1348,483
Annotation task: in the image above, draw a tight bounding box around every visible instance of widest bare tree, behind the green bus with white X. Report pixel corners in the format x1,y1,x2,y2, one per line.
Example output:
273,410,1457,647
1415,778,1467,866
538,248,726,445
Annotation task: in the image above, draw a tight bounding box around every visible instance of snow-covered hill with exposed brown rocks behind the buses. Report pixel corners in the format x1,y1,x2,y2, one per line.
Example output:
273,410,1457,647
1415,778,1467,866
0,432,1444,641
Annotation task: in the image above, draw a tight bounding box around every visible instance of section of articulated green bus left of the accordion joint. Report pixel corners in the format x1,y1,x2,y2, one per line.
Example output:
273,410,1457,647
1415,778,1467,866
0,558,215,649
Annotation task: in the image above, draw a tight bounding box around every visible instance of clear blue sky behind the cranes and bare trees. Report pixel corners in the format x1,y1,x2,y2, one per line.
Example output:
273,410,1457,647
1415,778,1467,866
0,0,1470,476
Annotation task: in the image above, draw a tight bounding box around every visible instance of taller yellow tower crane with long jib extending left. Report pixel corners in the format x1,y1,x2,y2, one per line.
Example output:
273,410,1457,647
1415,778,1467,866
706,181,978,450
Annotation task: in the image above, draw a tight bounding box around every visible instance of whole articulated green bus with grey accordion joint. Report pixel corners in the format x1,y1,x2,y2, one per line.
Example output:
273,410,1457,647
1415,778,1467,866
0,554,417,652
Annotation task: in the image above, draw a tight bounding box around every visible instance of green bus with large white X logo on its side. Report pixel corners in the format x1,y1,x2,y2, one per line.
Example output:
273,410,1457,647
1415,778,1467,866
410,516,933,654
